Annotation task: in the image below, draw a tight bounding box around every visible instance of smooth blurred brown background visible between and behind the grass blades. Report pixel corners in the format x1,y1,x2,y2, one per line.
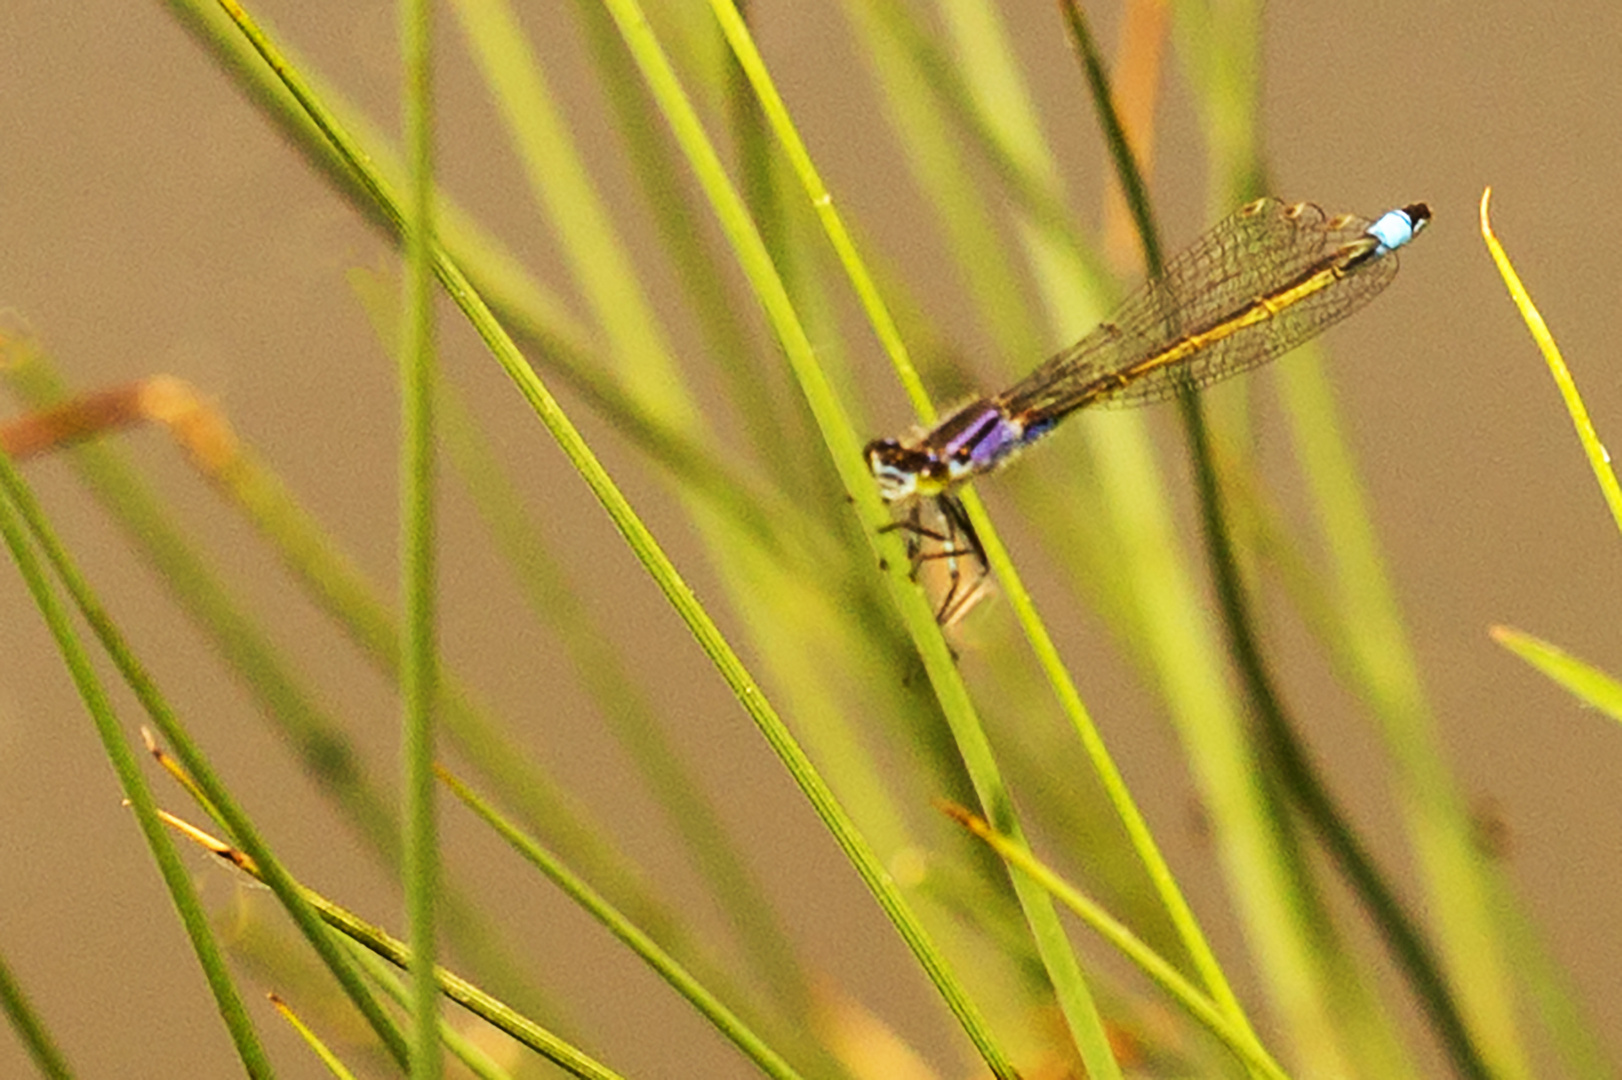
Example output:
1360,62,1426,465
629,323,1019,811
0,0,1622,1078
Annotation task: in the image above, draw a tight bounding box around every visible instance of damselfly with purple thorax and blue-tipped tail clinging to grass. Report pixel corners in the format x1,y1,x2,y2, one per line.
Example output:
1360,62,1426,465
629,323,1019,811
866,199,1431,623
